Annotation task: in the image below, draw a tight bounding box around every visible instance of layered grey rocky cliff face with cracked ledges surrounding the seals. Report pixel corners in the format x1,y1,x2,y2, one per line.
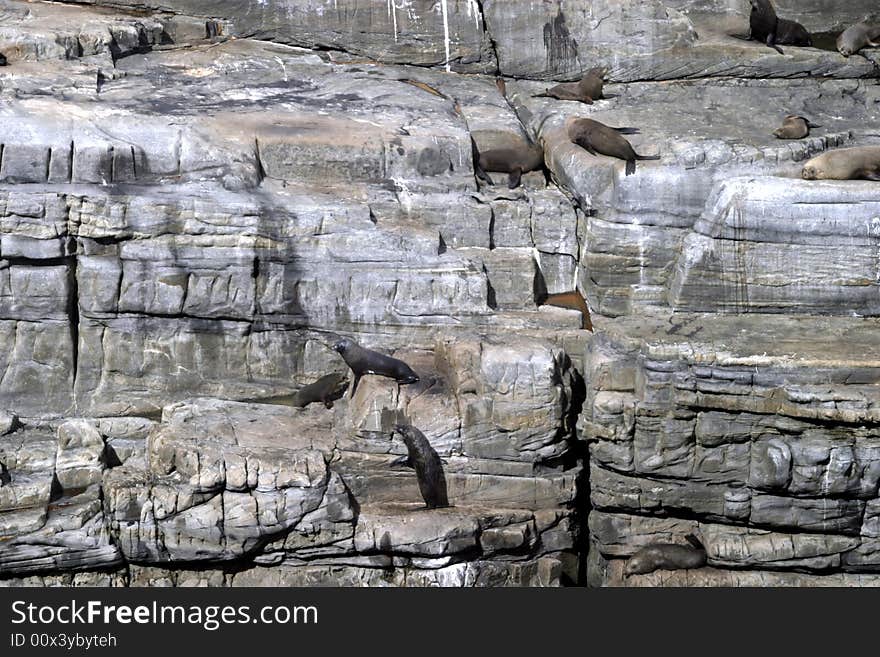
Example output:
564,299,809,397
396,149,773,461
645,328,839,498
0,0,880,586
